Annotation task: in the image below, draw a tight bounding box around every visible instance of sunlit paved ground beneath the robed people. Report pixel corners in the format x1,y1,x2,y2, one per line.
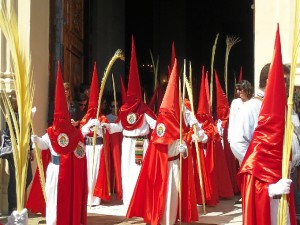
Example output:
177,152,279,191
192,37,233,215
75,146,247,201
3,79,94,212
0,196,242,225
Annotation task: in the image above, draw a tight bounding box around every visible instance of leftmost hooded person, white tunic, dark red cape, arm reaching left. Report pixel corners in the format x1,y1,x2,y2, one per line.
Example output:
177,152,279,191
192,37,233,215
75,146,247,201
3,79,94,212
31,62,87,225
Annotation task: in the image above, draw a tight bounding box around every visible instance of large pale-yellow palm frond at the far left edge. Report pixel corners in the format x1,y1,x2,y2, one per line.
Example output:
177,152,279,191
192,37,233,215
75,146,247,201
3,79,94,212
0,2,34,212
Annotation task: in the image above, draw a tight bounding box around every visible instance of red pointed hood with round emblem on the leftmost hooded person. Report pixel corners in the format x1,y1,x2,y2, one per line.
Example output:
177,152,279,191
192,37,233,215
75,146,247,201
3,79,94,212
47,62,82,154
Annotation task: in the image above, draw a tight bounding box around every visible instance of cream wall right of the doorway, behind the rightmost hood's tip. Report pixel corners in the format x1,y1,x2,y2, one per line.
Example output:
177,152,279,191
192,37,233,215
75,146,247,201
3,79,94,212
254,0,300,91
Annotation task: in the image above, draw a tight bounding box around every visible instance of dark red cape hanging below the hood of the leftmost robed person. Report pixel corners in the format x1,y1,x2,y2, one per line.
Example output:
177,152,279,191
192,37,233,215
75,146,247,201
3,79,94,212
56,140,88,225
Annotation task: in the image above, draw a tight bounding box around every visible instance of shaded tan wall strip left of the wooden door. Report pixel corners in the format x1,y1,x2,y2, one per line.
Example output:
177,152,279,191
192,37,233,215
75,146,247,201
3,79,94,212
27,0,50,200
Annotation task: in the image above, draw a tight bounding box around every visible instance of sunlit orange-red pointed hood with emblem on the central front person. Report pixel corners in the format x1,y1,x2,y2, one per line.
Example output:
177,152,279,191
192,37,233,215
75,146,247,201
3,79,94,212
152,59,180,145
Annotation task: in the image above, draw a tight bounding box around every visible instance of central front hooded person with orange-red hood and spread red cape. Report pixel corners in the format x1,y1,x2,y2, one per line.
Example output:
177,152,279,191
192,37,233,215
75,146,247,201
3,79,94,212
126,60,205,225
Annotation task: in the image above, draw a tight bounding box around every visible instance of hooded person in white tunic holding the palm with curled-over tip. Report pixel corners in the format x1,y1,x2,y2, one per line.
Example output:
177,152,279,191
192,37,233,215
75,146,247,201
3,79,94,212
79,63,111,206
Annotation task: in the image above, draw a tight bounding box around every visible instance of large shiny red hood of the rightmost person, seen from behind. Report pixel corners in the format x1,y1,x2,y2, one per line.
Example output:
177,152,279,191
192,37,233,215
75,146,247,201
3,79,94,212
238,23,287,183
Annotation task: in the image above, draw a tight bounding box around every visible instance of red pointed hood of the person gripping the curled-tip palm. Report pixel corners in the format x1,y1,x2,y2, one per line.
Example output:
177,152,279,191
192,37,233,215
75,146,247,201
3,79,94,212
80,62,99,128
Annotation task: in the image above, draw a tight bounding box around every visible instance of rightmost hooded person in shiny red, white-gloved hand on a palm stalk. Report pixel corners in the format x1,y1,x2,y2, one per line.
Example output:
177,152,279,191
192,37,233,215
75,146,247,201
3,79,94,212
237,24,297,225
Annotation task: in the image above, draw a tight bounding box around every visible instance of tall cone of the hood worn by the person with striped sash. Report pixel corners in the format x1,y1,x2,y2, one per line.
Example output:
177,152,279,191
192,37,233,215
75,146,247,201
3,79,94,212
127,36,142,99
